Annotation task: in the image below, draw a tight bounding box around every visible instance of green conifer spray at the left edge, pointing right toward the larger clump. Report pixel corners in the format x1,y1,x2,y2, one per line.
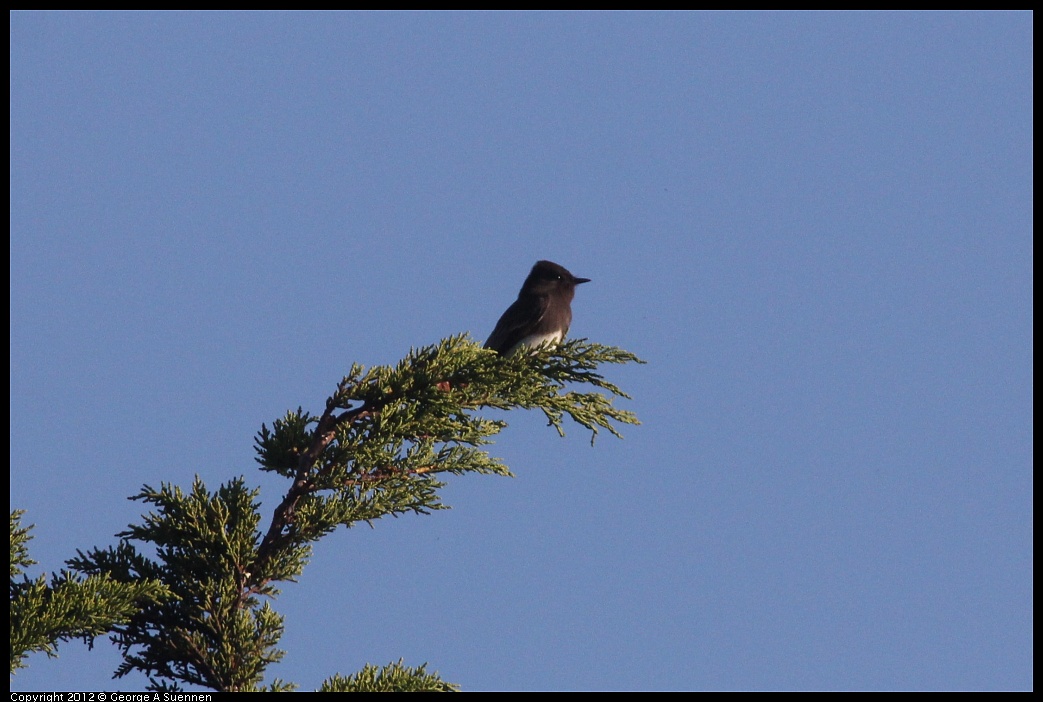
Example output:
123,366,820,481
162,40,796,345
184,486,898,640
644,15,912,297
10,510,168,674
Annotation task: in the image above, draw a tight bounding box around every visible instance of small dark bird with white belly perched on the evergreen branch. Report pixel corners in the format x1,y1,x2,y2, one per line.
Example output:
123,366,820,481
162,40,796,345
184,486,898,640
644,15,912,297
485,261,590,356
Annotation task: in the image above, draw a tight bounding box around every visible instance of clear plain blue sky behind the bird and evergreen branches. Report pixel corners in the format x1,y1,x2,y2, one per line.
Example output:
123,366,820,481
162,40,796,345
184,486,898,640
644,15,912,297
10,13,1033,691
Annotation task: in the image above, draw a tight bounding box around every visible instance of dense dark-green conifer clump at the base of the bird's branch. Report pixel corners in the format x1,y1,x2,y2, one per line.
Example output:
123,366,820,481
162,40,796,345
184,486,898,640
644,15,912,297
70,478,285,692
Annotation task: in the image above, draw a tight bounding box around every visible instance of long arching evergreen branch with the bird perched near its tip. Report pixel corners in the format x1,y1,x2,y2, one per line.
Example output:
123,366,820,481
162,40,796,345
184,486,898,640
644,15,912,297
252,336,640,577
